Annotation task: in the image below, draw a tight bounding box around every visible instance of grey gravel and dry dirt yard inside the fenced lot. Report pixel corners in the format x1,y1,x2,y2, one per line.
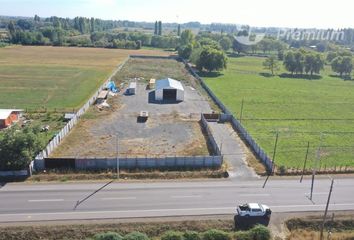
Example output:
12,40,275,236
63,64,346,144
51,60,212,158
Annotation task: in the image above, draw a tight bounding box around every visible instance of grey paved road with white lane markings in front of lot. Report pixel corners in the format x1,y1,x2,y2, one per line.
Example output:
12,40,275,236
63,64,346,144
0,179,354,222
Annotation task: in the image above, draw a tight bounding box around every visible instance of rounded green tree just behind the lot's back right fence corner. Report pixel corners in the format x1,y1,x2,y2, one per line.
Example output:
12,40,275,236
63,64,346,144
197,46,227,72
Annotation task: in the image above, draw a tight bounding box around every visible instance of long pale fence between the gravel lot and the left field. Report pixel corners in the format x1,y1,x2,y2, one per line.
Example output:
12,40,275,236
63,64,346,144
33,57,129,167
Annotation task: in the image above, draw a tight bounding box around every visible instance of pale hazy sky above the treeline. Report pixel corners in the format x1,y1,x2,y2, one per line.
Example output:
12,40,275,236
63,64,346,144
0,0,354,29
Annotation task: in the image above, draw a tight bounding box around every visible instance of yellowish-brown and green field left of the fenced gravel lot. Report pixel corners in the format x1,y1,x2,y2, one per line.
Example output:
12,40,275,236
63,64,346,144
0,46,169,110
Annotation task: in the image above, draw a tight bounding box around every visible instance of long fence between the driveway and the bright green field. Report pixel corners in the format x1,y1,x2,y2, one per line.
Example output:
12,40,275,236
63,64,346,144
182,59,273,171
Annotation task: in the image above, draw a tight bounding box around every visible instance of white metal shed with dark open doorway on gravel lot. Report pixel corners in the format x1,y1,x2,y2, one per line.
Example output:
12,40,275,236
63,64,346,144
155,78,184,102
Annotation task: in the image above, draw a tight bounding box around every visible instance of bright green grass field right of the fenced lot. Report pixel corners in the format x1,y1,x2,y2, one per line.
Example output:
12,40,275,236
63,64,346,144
204,57,354,168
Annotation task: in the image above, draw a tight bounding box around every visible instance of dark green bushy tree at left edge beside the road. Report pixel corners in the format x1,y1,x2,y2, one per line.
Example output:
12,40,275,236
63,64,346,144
0,126,45,171
